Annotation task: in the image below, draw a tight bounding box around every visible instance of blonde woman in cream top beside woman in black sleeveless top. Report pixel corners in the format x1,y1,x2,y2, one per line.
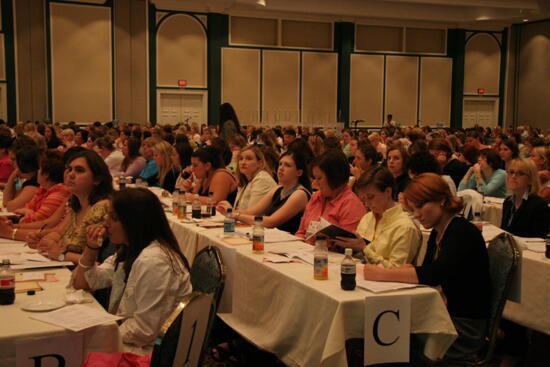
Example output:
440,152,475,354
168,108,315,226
234,145,277,210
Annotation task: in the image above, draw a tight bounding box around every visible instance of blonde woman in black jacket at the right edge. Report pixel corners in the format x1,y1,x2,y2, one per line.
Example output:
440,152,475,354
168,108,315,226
500,158,550,238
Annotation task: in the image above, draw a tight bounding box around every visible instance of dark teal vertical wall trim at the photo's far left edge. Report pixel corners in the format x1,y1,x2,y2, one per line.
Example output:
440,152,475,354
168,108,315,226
1,0,17,122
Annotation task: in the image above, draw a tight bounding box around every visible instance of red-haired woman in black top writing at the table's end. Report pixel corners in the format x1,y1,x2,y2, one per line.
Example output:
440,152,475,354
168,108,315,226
364,173,491,360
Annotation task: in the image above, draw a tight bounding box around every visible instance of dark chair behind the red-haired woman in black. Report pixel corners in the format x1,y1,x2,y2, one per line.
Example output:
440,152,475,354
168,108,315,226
436,233,520,366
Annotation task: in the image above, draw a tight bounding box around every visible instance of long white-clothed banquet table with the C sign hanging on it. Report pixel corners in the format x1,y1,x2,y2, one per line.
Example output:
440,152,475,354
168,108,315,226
168,214,456,367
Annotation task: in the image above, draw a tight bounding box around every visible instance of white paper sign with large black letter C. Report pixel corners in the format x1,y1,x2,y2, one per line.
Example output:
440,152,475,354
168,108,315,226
364,295,411,366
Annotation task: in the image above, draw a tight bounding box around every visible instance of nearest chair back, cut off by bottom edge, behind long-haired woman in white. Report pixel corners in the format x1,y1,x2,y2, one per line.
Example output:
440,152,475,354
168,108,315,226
151,291,214,367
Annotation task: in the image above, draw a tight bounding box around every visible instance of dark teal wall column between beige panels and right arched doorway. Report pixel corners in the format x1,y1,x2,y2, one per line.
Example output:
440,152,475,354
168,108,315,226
447,29,466,128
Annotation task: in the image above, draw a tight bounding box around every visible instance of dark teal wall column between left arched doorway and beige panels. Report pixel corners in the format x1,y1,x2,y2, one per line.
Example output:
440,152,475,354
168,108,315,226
207,13,229,125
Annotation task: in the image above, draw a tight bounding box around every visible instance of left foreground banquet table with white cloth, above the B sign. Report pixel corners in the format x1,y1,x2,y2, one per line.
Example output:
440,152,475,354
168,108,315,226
0,240,122,366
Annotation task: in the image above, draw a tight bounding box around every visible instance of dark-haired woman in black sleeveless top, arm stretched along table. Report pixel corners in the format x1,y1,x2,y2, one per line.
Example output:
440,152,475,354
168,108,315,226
218,151,311,234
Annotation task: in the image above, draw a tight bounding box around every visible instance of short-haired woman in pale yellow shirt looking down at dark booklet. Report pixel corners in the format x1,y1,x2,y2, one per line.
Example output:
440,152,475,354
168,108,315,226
335,167,422,268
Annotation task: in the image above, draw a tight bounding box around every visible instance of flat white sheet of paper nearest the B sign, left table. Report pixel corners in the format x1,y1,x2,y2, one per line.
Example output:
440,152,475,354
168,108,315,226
31,305,122,332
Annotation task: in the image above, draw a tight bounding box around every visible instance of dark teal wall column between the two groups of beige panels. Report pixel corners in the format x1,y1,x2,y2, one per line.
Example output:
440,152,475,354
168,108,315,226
334,22,355,127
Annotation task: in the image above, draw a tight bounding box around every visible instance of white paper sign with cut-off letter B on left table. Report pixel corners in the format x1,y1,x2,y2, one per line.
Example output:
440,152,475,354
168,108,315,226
15,333,82,367
